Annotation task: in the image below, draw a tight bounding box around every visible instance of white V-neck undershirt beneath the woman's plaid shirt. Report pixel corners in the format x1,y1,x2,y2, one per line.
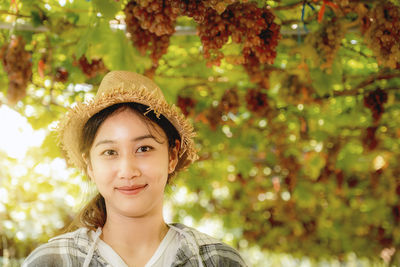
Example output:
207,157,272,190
90,228,179,267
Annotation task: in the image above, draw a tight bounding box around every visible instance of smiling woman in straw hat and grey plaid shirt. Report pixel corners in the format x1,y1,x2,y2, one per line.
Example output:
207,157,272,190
23,71,245,267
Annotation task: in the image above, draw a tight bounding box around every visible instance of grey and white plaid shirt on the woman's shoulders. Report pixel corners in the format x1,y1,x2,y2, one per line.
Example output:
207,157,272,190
22,224,247,267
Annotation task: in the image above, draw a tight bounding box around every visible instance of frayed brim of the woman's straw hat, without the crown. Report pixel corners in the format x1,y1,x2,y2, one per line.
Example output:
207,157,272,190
57,88,198,172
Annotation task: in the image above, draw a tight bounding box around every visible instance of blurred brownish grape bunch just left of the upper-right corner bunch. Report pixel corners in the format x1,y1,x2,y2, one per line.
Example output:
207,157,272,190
306,18,346,69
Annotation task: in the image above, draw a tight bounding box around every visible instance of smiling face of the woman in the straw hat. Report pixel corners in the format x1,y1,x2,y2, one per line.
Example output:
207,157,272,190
87,109,179,220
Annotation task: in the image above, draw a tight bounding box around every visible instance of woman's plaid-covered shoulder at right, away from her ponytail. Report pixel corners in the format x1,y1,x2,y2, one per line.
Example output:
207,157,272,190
171,223,247,266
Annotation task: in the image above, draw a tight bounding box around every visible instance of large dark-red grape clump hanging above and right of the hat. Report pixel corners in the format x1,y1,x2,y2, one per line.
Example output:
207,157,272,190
198,3,281,65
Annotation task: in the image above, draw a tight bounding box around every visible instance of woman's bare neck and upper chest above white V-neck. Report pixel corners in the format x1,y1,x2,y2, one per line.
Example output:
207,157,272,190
100,212,168,266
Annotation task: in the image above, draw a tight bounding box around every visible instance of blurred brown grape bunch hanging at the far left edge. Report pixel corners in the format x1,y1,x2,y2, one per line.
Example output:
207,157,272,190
0,36,32,105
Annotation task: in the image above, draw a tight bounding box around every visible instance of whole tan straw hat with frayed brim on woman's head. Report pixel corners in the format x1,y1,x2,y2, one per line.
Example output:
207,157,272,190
57,71,198,171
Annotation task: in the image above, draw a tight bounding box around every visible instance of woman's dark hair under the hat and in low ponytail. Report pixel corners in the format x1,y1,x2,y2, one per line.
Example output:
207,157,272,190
65,102,181,232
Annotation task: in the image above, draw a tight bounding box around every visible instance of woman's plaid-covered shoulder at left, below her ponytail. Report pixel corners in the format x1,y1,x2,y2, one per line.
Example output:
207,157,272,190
22,228,90,267
